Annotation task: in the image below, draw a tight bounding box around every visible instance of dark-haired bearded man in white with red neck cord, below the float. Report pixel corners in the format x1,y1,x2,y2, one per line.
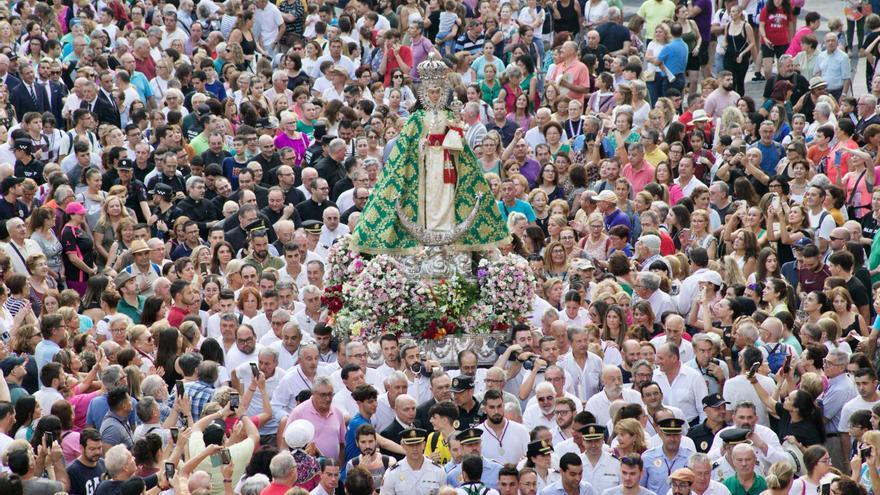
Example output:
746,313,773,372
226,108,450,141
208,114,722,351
480,390,529,464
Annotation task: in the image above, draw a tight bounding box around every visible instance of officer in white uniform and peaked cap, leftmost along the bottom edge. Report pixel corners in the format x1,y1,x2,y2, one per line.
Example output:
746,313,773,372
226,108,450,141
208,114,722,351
379,428,446,495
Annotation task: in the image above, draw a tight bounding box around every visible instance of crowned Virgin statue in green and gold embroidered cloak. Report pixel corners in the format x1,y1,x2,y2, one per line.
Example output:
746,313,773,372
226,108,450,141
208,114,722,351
352,56,508,254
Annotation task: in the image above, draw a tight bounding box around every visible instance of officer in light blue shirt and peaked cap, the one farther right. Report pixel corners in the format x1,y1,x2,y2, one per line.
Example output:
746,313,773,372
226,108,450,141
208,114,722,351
641,418,693,493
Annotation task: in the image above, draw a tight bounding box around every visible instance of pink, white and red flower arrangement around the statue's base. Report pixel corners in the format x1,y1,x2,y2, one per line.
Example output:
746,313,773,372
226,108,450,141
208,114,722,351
322,236,534,340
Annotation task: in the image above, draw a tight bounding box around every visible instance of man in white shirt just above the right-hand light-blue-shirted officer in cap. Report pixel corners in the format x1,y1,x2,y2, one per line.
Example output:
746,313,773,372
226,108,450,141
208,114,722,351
654,340,708,426
